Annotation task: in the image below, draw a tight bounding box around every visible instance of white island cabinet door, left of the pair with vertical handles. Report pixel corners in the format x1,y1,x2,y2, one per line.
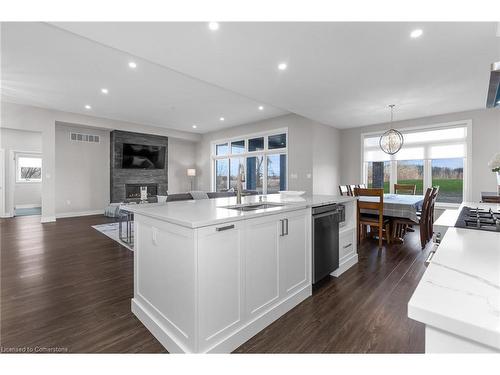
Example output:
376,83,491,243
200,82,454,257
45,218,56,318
245,215,281,317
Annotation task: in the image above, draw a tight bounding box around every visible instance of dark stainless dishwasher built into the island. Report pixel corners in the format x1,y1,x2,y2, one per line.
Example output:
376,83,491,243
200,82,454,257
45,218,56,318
312,204,345,284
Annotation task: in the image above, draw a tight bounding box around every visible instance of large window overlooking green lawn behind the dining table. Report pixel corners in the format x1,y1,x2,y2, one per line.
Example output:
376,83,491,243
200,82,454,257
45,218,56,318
363,122,470,204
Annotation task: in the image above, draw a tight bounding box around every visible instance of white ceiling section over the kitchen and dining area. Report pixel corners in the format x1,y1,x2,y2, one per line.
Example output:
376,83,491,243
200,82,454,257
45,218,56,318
52,22,500,128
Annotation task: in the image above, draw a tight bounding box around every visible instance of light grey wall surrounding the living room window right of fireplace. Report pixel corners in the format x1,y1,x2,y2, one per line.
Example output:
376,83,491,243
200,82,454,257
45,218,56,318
196,114,338,194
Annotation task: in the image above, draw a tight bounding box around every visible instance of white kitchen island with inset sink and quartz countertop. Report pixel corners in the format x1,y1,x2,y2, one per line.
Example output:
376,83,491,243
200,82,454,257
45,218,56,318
123,195,357,353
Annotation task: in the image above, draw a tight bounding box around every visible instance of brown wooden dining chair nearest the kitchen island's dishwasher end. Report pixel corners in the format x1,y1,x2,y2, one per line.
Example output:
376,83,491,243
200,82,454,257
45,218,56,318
354,188,391,248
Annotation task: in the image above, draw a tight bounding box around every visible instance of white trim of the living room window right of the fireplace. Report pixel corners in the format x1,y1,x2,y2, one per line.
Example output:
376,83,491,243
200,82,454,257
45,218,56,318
210,128,290,194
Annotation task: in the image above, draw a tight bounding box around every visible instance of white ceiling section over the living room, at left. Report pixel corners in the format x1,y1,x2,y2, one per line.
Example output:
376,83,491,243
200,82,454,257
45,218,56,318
2,23,287,133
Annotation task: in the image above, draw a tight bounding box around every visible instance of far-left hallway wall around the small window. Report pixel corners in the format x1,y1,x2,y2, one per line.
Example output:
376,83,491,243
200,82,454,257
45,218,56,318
0,129,42,216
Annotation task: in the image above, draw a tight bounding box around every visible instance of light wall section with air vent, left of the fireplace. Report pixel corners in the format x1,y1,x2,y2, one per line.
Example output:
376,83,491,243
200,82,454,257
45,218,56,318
55,123,110,217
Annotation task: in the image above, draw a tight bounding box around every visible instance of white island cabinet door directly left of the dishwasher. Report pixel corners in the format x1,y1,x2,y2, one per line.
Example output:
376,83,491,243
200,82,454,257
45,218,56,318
279,211,311,297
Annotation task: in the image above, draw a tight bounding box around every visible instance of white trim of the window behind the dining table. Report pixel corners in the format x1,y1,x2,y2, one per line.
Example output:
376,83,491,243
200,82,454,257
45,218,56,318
360,119,472,208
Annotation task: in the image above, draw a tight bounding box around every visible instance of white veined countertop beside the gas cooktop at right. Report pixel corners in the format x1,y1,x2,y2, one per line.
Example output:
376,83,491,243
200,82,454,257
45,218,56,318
408,210,500,350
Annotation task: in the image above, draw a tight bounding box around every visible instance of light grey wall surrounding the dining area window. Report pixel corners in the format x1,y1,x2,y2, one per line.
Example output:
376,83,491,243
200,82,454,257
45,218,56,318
340,109,500,202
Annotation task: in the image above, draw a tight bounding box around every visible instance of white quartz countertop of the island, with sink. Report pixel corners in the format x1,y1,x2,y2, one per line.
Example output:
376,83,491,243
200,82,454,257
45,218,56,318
122,194,356,228
